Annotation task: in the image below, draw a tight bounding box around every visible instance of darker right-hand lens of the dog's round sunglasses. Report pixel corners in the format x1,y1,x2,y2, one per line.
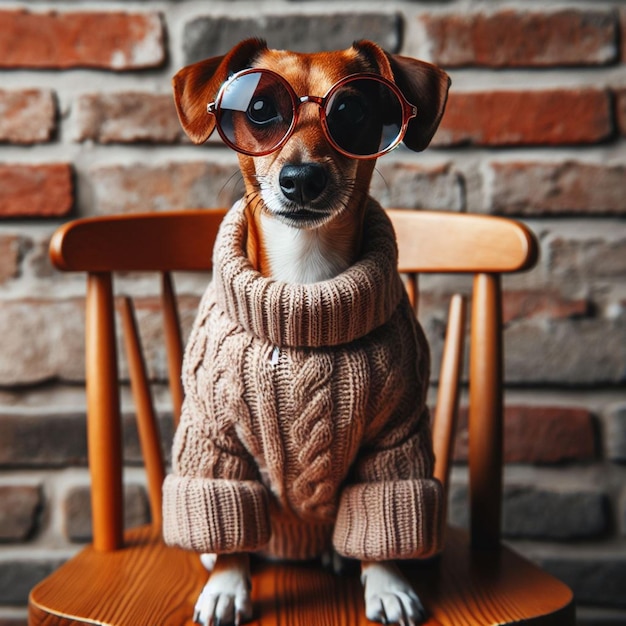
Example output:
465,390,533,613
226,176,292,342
325,78,402,156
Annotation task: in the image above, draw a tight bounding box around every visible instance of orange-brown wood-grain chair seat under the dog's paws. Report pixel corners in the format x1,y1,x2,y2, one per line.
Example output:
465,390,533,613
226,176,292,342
29,527,574,626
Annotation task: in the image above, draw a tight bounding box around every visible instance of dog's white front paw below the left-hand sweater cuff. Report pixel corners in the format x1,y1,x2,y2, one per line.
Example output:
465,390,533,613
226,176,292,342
193,552,252,626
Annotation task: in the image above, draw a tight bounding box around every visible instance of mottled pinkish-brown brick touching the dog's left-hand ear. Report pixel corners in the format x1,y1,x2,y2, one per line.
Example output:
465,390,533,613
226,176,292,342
76,92,185,143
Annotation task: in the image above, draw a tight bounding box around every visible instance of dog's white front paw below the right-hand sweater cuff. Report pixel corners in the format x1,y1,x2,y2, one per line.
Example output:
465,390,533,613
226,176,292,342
361,562,426,626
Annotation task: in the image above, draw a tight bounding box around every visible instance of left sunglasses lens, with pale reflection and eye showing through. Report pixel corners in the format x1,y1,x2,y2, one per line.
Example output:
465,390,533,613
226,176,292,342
218,72,294,154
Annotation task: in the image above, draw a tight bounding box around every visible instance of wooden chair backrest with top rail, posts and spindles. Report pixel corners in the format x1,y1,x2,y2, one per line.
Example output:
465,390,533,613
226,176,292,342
50,209,537,551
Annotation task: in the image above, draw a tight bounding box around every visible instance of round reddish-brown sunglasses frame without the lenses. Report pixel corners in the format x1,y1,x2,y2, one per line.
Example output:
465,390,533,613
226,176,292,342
207,68,417,160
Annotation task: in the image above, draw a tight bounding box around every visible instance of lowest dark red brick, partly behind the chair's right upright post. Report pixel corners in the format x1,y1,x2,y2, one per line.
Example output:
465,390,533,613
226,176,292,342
454,406,596,464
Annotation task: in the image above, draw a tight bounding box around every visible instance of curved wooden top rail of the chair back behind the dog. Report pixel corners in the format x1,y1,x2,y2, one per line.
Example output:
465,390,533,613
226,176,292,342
50,209,537,273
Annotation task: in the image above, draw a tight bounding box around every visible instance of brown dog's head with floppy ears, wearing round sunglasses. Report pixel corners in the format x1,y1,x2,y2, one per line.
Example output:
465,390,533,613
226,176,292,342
173,39,450,227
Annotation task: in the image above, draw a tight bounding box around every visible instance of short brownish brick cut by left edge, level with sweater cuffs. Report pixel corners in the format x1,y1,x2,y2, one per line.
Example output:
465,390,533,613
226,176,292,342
0,484,42,541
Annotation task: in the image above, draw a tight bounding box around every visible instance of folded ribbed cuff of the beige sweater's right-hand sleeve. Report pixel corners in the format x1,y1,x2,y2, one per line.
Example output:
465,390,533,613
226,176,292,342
333,479,444,561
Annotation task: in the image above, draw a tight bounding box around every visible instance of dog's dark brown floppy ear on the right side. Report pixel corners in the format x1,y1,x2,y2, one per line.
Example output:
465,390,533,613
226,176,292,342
354,41,450,152
